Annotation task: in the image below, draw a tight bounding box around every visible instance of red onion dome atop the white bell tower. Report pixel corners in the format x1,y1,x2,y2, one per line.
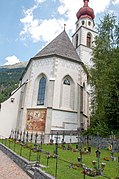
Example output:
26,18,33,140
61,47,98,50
76,0,95,20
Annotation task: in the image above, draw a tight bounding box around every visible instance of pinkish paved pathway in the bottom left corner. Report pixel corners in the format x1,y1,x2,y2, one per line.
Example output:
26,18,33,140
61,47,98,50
0,151,31,179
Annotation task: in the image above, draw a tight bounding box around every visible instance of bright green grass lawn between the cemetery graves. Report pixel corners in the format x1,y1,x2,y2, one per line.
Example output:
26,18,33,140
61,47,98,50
2,140,119,179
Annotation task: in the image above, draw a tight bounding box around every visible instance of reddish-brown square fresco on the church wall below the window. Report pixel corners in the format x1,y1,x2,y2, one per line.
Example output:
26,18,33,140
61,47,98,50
26,109,46,132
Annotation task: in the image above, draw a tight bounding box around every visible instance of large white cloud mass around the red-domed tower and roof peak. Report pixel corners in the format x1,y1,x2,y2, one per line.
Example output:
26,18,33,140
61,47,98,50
20,0,119,42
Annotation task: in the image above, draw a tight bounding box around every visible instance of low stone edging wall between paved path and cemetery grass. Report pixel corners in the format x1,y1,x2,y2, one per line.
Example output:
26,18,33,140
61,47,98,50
0,143,55,179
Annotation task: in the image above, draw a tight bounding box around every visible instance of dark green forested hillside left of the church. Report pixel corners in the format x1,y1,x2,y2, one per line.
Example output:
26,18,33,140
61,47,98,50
0,67,24,103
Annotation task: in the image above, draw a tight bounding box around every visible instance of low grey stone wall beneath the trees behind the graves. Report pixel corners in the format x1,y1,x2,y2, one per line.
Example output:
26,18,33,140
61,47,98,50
82,136,119,152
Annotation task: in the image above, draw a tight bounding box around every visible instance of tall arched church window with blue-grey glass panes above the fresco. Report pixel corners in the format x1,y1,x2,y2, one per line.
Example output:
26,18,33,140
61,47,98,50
37,76,46,105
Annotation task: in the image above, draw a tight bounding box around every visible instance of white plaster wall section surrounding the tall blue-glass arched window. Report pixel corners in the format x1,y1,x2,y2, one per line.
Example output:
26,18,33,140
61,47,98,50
19,58,53,129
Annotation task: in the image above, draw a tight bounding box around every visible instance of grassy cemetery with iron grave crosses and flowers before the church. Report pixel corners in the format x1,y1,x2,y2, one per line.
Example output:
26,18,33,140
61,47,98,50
0,131,119,179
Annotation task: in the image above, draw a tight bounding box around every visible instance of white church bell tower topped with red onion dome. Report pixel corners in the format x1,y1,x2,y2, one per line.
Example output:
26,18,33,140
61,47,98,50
72,0,97,68
